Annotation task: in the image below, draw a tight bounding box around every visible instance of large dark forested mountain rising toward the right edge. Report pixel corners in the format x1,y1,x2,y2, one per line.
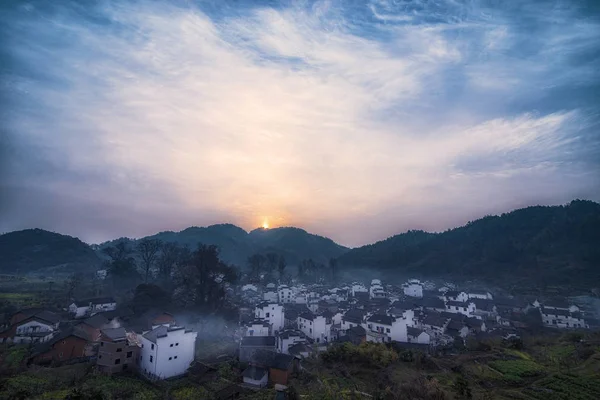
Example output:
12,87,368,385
338,200,600,287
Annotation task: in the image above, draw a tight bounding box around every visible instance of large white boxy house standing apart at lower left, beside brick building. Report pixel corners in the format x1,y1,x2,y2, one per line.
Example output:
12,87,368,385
139,325,197,379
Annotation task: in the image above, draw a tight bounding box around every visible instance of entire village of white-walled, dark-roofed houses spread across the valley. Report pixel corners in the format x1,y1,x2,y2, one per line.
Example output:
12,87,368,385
0,279,597,398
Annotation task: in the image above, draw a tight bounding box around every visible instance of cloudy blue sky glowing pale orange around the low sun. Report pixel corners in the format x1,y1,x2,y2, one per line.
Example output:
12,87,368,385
0,0,600,246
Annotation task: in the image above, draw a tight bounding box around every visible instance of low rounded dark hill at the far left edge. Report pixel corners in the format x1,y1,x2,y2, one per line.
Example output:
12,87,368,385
0,229,100,273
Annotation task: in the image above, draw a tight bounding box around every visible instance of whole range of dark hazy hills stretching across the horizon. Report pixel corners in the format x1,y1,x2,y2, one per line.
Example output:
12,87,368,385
0,200,600,287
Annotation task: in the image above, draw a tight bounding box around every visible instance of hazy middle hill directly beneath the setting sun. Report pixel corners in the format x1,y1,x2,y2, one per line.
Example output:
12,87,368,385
96,224,348,266
